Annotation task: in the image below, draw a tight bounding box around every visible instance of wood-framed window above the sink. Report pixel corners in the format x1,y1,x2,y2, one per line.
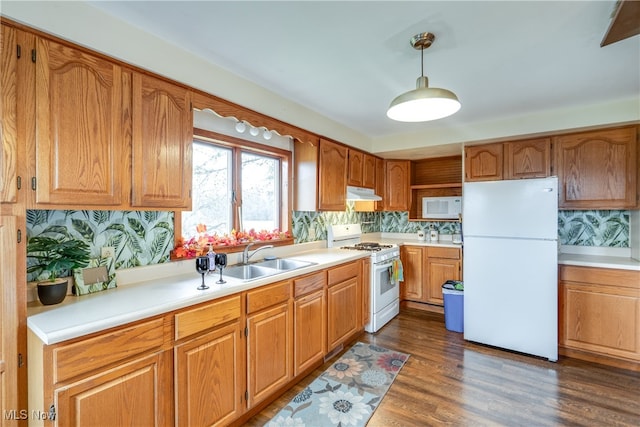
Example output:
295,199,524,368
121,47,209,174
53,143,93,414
176,130,291,246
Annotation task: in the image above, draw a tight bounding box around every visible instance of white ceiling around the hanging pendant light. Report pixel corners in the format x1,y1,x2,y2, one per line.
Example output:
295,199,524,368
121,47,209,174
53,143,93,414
89,0,640,145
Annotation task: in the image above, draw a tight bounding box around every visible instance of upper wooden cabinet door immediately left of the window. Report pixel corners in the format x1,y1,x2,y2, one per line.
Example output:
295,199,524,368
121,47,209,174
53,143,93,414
131,73,193,209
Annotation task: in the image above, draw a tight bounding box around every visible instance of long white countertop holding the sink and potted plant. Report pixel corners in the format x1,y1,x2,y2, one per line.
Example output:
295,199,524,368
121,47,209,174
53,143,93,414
27,248,368,344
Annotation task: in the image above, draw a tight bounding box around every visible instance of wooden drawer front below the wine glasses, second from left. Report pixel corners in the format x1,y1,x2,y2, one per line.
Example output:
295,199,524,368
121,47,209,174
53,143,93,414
175,295,240,341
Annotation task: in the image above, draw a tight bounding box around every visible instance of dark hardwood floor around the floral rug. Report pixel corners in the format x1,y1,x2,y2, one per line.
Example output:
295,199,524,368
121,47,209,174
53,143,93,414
246,309,640,427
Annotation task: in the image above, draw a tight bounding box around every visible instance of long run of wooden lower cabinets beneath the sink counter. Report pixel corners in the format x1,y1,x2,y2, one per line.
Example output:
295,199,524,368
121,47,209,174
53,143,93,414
28,260,366,427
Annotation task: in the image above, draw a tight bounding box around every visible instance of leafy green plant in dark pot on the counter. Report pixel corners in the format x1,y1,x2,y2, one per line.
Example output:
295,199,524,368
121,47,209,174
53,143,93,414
27,235,90,305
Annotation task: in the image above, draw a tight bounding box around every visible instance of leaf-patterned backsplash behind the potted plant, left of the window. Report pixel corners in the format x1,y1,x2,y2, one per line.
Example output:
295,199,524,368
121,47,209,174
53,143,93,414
27,210,174,280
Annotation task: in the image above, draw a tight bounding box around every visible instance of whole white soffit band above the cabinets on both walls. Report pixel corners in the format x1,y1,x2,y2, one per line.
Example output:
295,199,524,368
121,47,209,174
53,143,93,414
0,0,640,159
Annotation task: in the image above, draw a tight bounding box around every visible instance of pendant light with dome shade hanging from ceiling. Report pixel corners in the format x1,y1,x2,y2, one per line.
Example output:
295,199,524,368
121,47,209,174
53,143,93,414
387,33,460,122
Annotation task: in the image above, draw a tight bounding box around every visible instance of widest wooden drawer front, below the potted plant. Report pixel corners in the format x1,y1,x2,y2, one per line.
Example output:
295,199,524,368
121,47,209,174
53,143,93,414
52,318,164,383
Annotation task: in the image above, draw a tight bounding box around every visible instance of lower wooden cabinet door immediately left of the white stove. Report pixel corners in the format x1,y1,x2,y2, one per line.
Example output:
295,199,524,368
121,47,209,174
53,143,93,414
327,277,361,351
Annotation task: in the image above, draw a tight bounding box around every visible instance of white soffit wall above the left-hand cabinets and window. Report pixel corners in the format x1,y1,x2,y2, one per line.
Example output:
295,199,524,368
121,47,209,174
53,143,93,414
0,0,371,151
